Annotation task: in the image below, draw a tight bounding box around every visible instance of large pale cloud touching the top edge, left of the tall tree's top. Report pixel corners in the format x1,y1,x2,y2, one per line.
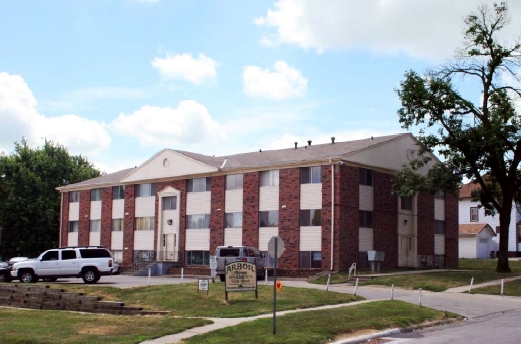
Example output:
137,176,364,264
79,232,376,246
254,0,521,59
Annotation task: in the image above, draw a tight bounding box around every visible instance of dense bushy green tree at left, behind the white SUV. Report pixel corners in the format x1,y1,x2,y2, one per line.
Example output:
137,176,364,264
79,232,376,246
0,139,100,259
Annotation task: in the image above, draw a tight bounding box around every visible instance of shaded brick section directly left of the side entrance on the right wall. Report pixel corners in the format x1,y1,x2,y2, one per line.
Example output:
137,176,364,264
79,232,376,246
373,171,398,267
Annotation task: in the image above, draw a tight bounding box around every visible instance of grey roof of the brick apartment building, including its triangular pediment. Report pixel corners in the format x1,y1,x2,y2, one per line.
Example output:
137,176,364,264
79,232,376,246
58,133,422,191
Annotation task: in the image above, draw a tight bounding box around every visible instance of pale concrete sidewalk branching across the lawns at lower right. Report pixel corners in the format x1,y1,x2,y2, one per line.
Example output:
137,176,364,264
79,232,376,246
142,276,521,344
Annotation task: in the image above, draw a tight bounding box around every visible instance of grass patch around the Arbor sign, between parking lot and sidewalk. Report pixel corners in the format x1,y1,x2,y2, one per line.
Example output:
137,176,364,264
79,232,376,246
52,283,363,318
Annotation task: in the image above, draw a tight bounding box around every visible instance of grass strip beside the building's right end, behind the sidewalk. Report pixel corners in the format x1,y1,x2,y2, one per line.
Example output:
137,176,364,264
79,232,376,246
310,259,521,292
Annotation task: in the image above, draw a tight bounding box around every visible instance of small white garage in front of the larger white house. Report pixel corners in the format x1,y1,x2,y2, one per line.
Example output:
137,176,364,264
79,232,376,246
459,223,496,258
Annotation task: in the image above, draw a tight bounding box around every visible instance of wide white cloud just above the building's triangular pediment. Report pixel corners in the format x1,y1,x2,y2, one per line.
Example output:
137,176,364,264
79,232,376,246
111,100,226,147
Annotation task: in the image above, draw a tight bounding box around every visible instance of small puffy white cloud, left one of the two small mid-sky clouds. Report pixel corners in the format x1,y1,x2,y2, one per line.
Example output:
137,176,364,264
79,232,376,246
150,53,217,85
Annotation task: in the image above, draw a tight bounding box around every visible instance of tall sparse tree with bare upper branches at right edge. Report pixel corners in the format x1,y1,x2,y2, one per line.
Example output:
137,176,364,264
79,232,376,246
395,2,521,272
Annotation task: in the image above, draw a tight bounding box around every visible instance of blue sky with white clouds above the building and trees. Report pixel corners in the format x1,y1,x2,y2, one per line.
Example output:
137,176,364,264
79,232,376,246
0,0,521,173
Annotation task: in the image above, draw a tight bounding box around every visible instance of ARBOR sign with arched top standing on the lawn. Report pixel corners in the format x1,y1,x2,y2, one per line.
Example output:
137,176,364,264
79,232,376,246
224,261,257,292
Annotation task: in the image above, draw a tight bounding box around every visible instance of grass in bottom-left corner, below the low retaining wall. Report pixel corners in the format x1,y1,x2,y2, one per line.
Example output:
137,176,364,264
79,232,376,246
0,308,212,344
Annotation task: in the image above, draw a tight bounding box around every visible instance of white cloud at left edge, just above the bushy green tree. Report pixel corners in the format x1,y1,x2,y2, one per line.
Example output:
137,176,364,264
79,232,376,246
0,72,110,155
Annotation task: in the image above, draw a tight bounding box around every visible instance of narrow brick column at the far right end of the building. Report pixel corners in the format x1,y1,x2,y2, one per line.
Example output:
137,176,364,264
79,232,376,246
445,195,459,268
